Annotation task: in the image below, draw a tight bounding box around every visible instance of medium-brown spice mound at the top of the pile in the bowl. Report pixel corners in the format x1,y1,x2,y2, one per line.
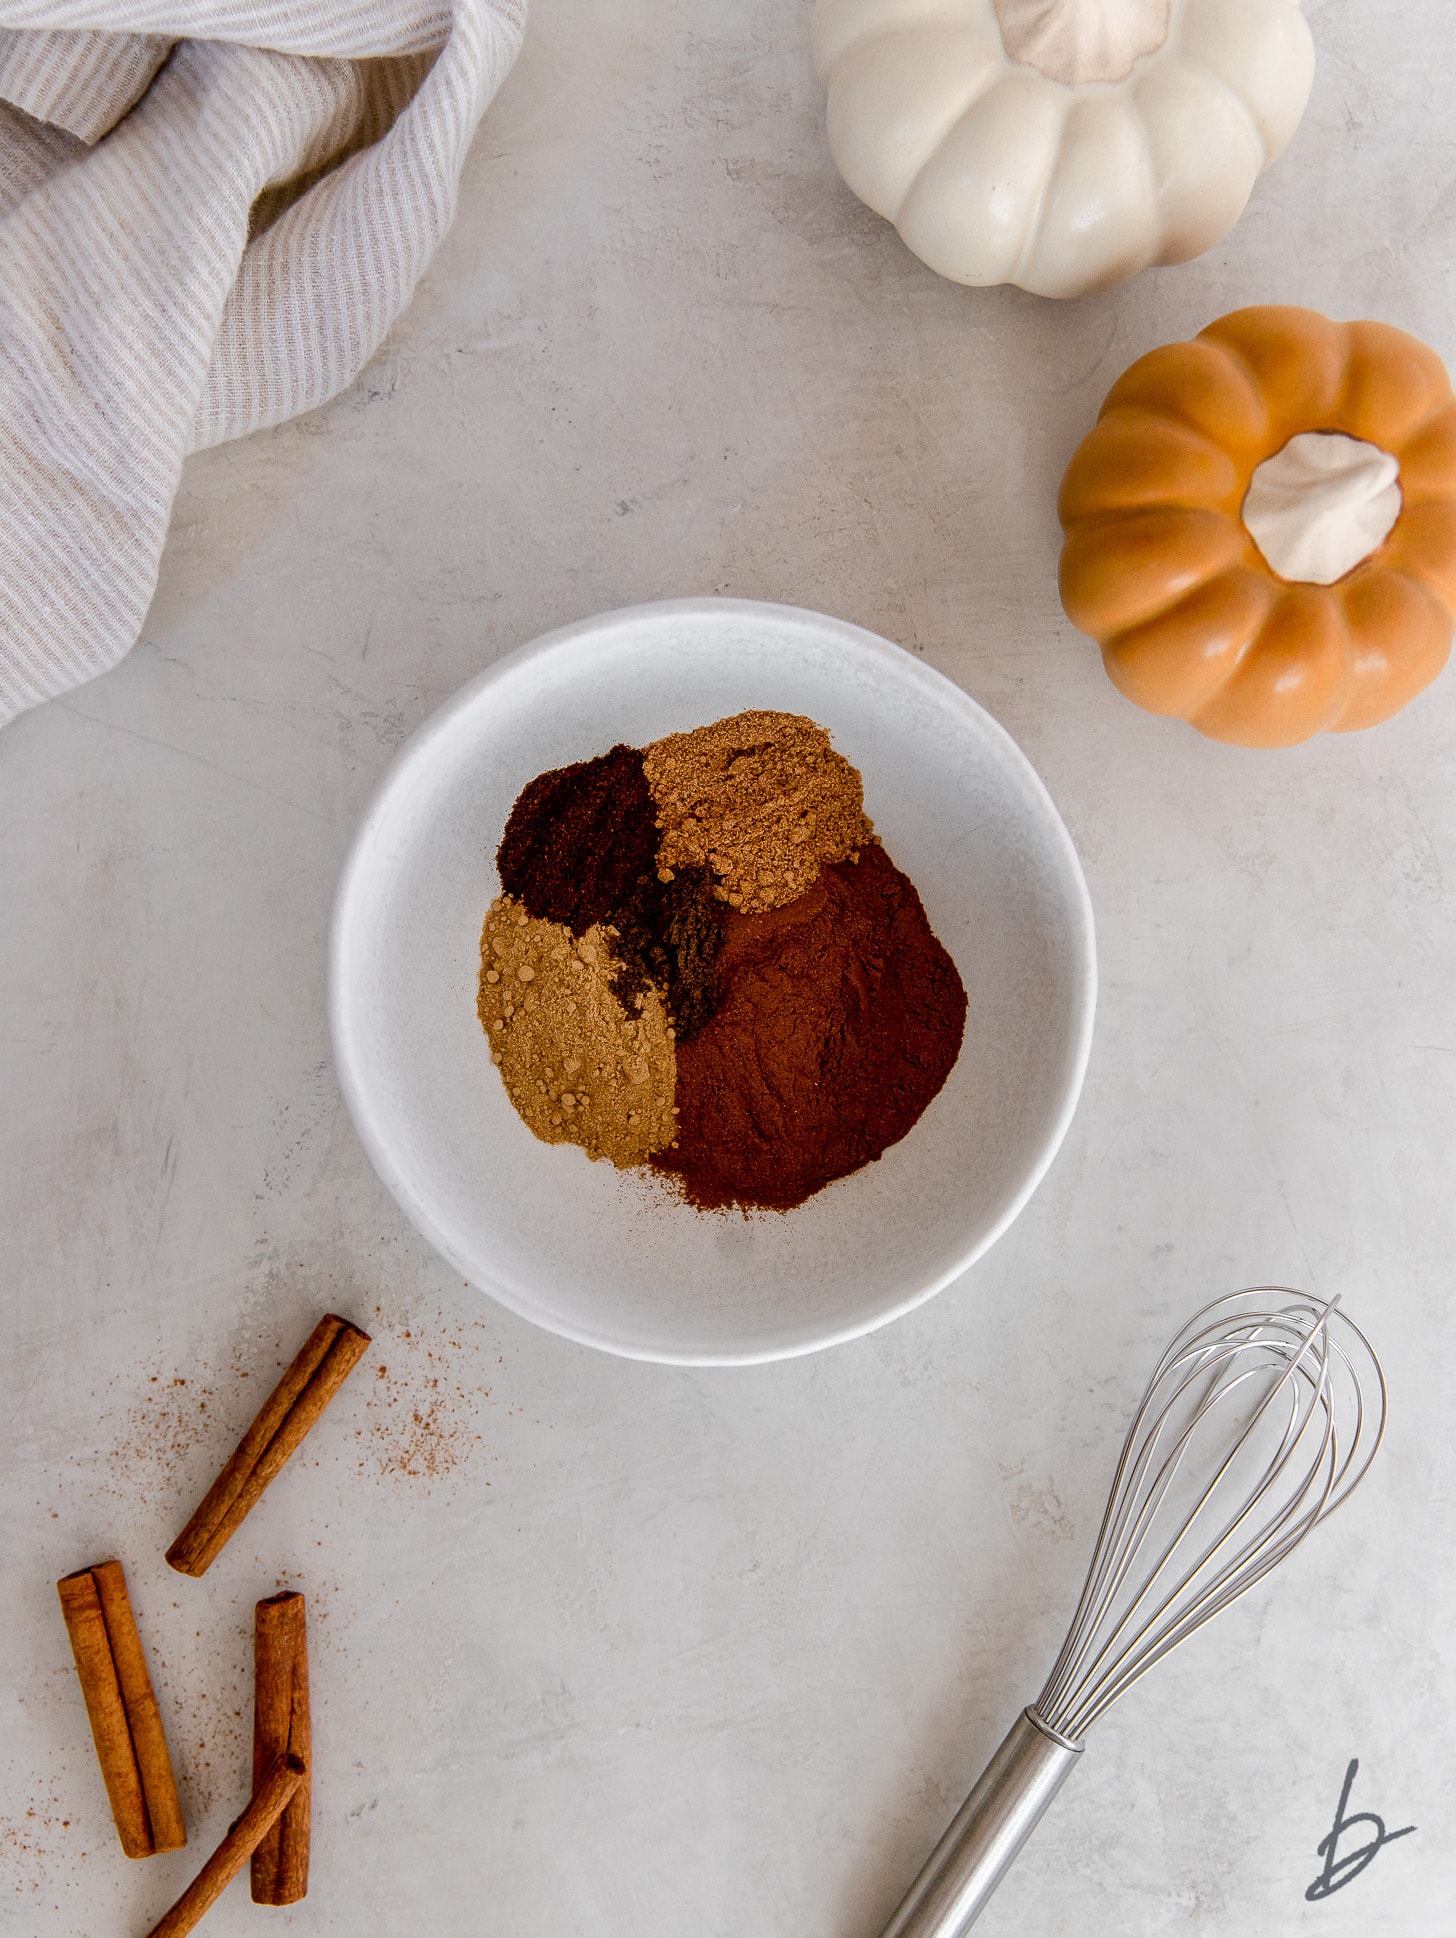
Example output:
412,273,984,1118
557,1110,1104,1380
644,709,874,915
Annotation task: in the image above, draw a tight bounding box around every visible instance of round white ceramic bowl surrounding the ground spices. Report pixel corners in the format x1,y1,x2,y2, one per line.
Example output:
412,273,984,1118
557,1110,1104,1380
330,599,1095,1364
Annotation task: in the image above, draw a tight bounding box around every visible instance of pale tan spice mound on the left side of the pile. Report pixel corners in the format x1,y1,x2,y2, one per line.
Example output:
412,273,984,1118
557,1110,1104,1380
477,895,677,1167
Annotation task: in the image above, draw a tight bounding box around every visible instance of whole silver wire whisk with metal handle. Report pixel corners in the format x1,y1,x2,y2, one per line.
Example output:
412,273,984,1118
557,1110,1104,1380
884,1287,1386,1938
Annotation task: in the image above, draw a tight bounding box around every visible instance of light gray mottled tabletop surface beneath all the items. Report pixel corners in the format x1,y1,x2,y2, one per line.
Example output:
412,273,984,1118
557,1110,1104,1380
0,0,1456,1938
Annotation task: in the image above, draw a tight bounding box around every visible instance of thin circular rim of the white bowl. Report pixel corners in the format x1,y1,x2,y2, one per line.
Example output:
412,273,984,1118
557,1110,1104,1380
328,595,1097,1366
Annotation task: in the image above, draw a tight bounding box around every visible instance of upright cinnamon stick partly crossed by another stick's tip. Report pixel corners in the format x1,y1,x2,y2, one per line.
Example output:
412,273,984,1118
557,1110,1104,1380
252,1593,312,1905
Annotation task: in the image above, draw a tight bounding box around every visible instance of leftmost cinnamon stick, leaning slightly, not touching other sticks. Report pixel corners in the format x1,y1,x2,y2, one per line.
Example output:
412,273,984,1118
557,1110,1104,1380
56,1560,186,1857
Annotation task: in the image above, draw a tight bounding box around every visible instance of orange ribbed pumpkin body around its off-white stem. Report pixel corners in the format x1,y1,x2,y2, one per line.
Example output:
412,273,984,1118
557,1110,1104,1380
1059,304,1456,746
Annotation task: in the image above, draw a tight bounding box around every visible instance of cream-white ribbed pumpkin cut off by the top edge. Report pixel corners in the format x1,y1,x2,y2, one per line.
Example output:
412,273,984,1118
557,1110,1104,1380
814,0,1314,297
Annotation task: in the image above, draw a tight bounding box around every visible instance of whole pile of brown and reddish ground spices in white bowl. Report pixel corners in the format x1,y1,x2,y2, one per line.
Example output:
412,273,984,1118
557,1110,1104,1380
477,711,965,1211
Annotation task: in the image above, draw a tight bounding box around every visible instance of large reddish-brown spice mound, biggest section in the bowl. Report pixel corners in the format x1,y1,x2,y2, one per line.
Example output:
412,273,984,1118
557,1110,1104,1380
653,845,965,1211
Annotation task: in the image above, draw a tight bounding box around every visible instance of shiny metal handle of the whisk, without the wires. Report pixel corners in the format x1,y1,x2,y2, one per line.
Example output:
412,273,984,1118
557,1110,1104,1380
884,1709,1082,1938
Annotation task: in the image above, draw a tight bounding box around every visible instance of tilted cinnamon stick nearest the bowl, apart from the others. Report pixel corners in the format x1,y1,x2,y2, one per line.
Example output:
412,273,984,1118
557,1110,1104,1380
167,1312,368,1576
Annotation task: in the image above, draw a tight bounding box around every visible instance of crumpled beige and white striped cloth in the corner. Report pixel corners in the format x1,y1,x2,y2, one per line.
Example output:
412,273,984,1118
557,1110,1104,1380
0,0,525,723
